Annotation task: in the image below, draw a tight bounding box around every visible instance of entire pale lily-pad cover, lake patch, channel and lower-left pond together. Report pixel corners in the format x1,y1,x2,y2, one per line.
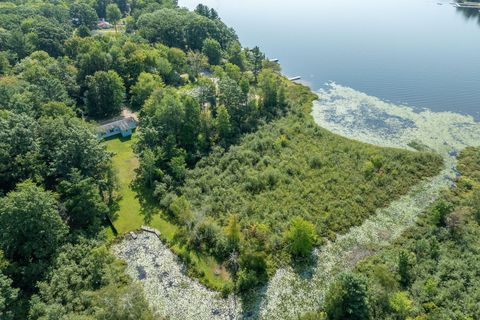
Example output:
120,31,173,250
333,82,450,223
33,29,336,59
114,84,480,319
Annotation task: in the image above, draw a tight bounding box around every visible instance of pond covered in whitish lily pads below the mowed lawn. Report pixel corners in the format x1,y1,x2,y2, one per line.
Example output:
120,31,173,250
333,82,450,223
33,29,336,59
112,232,241,320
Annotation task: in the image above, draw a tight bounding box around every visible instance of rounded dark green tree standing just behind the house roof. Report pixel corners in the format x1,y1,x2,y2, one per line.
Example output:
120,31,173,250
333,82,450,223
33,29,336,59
85,70,125,119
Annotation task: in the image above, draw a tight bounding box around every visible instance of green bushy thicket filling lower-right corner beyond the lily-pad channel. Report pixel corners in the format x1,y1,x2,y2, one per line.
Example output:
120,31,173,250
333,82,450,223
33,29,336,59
312,148,480,320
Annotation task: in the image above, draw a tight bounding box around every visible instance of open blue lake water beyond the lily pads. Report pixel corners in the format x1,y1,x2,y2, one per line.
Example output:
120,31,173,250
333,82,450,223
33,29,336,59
179,0,480,120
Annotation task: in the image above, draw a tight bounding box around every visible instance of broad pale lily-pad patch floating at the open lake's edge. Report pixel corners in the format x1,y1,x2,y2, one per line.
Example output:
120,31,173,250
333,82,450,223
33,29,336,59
312,83,480,155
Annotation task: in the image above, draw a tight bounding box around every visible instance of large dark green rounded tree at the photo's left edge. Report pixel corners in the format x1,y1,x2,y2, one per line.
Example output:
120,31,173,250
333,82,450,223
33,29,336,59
0,181,68,289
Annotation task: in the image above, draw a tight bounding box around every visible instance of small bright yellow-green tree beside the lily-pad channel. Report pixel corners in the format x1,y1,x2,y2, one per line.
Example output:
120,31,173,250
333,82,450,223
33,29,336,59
285,217,316,257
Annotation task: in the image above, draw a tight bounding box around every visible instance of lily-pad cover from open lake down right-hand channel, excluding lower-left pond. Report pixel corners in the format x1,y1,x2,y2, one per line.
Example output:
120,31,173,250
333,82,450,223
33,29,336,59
260,84,480,319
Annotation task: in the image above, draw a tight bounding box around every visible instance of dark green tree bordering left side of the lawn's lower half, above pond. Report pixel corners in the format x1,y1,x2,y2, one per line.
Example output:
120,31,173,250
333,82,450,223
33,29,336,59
58,170,108,229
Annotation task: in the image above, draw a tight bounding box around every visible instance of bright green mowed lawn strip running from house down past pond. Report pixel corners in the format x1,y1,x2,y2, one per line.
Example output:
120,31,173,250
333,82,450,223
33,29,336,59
105,134,231,290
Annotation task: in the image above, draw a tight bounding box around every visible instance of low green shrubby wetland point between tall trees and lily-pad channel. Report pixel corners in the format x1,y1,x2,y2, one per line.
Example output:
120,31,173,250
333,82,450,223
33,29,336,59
182,84,443,256
